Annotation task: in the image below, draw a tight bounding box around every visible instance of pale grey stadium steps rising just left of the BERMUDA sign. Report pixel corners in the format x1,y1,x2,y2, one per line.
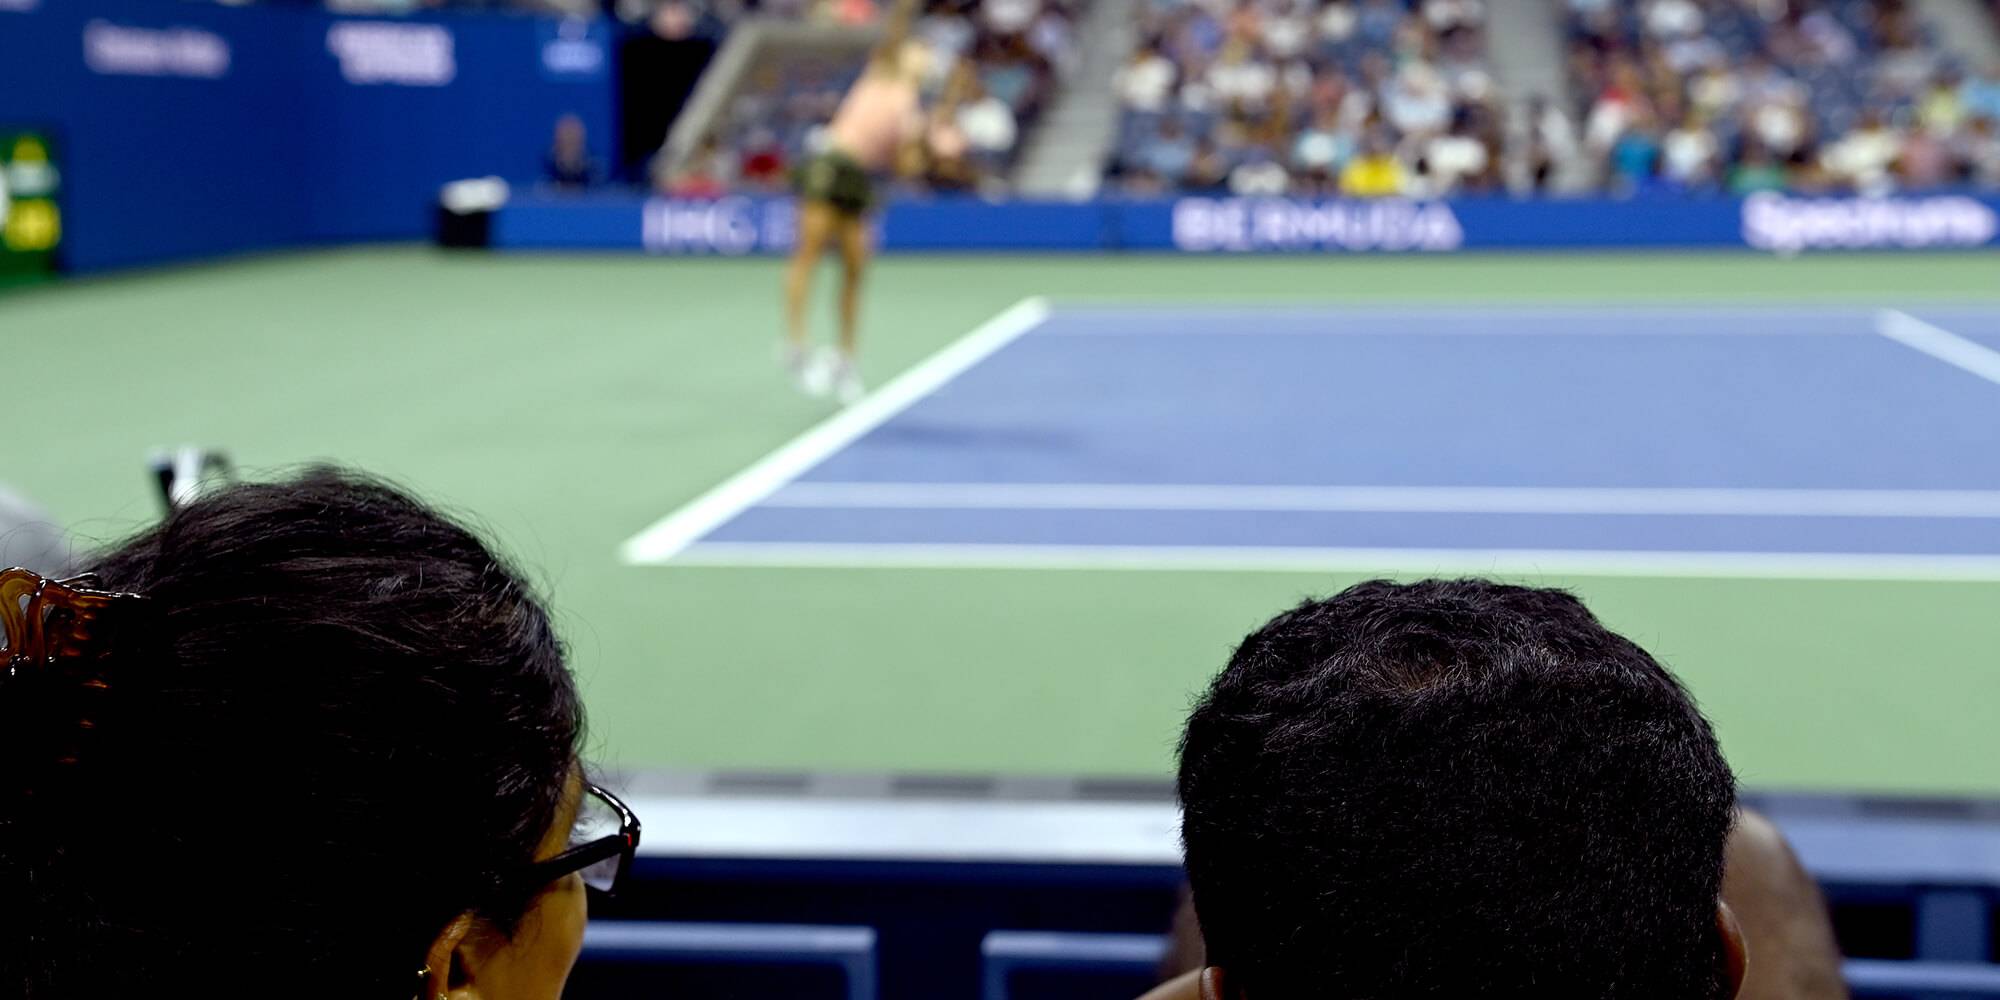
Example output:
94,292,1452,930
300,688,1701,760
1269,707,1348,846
1014,0,1138,198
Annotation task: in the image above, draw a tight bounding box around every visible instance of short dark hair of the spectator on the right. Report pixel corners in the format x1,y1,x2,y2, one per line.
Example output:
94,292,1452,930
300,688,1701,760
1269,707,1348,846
1180,580,1736,1000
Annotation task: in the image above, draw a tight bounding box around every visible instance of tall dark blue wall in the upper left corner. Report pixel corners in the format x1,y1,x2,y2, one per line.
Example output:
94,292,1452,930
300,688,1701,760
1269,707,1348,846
0,0,614,270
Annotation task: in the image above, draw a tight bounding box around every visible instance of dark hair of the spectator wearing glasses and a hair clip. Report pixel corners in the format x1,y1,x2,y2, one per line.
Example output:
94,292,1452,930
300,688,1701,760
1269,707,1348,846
0,470,582,1000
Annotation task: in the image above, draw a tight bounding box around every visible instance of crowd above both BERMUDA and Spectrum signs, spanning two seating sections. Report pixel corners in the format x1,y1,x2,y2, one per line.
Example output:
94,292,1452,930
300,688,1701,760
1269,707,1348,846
1110,0,2000,196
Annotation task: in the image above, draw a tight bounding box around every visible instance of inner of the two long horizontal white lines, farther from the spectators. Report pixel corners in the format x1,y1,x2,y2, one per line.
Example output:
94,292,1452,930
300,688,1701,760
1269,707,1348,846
762,482,2000,518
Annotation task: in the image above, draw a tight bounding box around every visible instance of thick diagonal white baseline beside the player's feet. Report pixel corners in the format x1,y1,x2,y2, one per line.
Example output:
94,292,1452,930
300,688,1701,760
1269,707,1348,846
618,296,1048,566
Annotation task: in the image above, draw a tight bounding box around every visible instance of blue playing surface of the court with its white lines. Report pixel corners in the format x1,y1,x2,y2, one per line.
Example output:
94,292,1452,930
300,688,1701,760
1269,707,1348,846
624,300,2000,580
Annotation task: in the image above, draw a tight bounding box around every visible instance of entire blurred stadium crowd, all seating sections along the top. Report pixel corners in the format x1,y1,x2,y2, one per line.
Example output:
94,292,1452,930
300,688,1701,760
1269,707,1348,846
266,0,2000,198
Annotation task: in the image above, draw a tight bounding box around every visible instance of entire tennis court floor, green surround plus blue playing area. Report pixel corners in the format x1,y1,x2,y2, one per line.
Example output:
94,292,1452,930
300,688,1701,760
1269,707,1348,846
11,248,2000,796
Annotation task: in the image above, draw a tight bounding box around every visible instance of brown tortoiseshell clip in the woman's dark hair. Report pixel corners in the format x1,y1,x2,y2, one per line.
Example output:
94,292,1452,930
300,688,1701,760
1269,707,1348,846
0,566,146,688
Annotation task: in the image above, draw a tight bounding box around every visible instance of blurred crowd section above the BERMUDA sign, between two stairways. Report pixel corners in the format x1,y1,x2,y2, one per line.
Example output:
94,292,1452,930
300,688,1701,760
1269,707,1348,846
1110,0,1504,196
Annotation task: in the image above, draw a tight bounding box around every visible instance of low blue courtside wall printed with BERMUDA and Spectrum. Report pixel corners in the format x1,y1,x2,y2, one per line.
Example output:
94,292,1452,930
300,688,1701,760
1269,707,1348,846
492,194,2000,256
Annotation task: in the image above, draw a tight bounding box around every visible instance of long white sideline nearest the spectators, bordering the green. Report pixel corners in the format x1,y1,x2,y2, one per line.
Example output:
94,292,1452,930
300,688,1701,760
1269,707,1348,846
674,542,2000,580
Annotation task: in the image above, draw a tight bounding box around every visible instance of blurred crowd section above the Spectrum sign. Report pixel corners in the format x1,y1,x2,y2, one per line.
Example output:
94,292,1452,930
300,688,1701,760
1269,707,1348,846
1560,0,2000,194
